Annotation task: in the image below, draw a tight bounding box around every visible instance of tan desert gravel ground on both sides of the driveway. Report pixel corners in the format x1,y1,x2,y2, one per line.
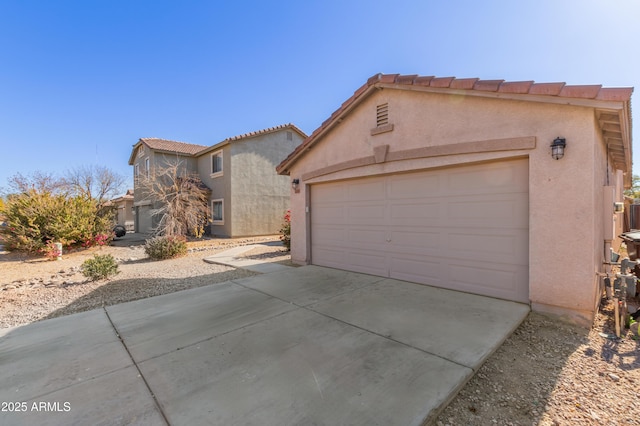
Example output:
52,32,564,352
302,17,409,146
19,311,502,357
0,236,640,426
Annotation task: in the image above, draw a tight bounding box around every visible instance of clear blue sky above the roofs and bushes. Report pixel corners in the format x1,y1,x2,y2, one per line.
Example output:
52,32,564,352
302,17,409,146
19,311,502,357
0,0,640,193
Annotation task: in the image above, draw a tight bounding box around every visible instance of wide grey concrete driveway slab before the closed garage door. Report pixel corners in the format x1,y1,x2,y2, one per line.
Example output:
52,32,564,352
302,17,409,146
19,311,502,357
0,266,529,426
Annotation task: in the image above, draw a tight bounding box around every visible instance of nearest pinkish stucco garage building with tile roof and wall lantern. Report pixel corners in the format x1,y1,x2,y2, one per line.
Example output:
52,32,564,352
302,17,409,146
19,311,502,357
278,74,633,324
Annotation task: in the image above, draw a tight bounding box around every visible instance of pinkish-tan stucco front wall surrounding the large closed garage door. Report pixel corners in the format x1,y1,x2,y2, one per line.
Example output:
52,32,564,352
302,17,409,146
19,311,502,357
290,89,615,324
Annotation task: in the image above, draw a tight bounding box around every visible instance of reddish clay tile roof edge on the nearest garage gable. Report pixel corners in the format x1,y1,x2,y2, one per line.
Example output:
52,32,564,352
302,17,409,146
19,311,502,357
276,74,633,174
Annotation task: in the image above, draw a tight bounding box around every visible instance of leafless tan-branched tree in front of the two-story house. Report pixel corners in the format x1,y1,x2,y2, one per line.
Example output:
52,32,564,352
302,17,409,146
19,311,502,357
136,161,211,237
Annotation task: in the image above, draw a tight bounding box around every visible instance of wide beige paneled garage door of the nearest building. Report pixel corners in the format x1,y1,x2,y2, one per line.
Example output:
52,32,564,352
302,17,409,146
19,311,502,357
311,159,529,302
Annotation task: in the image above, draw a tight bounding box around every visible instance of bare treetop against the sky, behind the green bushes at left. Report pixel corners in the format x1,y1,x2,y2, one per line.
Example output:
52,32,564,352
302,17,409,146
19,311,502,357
63,166,125,205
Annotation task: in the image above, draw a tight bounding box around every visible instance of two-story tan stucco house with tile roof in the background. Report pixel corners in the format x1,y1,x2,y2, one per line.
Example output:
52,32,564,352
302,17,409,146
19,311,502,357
129,124,306,237
